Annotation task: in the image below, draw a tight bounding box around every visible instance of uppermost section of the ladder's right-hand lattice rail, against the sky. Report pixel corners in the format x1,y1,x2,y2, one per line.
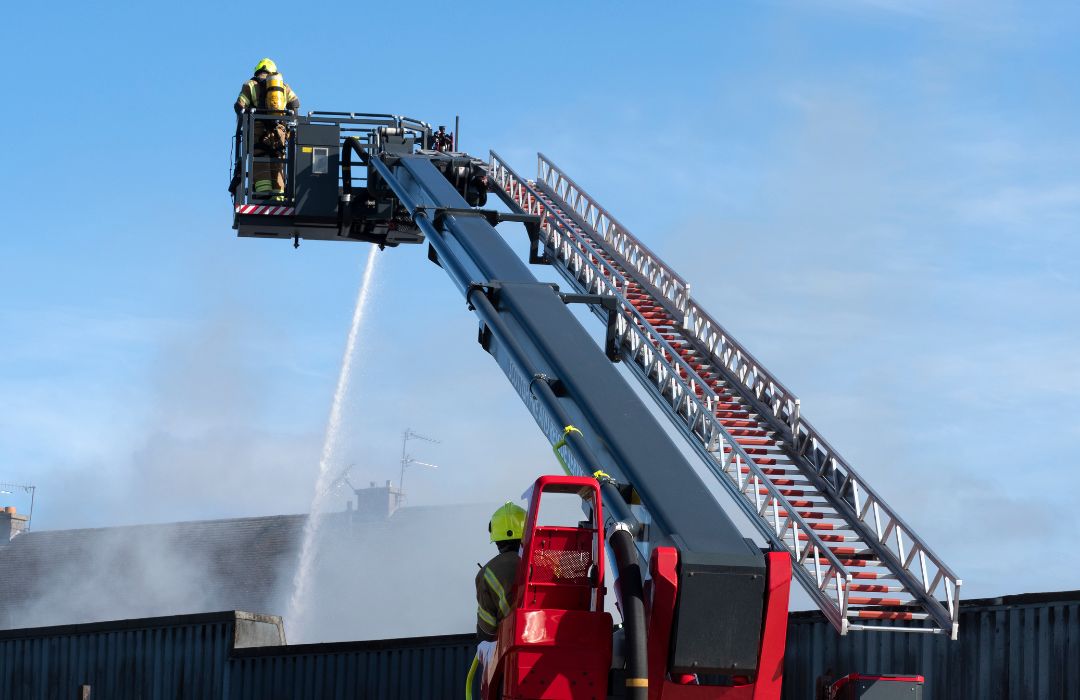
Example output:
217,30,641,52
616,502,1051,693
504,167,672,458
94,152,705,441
537,153,690,320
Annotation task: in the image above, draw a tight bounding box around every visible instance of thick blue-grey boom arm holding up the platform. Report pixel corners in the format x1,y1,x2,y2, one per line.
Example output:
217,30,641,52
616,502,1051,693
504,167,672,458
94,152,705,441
372,154,765,673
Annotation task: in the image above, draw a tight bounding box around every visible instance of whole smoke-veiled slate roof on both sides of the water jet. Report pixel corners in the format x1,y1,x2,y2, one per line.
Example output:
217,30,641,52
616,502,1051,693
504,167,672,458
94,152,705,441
0,504,494,641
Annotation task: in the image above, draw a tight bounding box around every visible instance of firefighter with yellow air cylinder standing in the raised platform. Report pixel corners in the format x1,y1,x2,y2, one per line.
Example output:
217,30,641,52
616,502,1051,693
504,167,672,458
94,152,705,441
232,58,300,201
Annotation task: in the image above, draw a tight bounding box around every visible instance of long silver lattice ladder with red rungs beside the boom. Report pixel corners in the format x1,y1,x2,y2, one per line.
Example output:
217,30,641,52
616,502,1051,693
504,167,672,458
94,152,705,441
489,151,961,640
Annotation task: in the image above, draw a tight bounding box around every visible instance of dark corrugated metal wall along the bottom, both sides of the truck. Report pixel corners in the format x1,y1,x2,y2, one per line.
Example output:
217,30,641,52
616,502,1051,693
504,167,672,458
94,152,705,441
0,591,1080,700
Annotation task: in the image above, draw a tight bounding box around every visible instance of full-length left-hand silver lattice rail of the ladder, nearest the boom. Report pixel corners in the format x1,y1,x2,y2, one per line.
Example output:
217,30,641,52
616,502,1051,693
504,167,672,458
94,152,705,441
495,157,868,633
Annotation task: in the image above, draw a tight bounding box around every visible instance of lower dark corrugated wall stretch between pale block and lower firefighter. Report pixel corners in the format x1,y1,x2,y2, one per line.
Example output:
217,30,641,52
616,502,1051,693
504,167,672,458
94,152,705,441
227,634,476,700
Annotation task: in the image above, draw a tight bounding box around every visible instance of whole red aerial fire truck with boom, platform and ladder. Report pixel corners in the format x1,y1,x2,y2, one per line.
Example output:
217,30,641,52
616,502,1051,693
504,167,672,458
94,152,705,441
230,111,961,700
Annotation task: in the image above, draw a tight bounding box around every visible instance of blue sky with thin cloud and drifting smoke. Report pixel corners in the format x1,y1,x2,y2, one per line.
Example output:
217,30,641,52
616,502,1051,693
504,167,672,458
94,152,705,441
0,0,1080,596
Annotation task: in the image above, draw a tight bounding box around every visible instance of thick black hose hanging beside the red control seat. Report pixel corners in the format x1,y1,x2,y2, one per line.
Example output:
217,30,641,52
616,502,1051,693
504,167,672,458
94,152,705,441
608,528,649,700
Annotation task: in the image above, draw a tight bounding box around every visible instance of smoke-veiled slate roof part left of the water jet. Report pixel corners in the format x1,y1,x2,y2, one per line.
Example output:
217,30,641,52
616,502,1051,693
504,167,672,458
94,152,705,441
0,515,307,629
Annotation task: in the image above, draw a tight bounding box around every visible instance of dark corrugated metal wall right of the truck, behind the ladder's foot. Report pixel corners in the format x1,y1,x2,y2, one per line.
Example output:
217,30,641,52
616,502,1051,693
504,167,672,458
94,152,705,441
784,591,1080,700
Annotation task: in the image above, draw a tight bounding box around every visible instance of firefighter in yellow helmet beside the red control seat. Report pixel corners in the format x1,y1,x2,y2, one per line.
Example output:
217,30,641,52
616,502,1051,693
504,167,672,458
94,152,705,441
476,501,525,665
